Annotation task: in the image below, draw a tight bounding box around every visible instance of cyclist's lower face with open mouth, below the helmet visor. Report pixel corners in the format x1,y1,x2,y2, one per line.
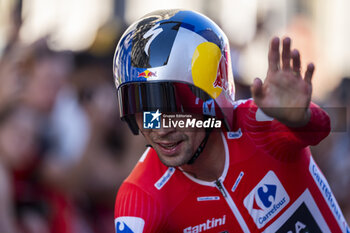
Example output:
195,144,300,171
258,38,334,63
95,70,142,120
136,114,205,167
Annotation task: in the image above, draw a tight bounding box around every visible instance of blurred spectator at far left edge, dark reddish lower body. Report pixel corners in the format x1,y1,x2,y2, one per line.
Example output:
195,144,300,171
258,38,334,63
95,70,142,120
0,103,49,233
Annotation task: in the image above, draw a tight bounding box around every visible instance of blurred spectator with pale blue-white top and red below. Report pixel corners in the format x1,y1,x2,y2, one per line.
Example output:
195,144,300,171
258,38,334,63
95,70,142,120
23,39,89,233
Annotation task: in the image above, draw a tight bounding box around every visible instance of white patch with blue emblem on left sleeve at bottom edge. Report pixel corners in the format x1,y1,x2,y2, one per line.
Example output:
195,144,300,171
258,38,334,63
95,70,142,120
114,216,145,233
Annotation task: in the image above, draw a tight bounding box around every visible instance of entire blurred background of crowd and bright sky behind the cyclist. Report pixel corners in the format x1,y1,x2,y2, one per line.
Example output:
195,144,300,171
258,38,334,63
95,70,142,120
0,0,350,233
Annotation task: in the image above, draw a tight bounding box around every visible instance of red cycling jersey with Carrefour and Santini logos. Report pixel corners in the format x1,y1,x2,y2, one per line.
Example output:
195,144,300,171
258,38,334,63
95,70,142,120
115,100,350,233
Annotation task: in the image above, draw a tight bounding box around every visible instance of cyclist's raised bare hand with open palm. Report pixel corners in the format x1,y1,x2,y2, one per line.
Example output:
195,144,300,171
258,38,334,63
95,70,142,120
251,37,315,127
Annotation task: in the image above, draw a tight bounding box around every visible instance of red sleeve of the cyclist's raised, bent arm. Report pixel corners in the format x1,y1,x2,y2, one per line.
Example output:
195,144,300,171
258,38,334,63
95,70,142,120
238,100,330,160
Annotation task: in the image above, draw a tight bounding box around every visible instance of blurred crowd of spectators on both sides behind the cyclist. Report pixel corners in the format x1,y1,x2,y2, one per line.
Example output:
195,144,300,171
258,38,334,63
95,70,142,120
0,2,350,233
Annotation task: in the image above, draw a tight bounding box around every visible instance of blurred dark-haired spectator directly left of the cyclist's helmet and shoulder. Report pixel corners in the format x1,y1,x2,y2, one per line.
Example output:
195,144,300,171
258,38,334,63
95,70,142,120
69,53,144,233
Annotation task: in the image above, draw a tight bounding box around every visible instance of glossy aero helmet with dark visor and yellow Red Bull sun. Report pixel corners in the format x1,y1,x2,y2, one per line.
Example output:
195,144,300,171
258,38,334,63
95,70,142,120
113,10,235,134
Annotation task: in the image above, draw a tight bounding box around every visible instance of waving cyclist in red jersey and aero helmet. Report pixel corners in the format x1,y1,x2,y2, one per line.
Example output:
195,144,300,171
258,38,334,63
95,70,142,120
114,10,349,233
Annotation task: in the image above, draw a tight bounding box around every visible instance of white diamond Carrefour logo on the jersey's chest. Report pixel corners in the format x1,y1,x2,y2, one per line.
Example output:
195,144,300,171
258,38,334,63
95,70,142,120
243,171,290,229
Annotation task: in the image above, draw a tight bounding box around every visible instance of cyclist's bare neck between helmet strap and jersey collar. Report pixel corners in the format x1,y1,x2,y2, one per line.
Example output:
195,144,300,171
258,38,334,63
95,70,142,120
181,131,225,181
